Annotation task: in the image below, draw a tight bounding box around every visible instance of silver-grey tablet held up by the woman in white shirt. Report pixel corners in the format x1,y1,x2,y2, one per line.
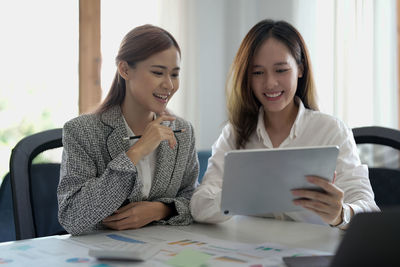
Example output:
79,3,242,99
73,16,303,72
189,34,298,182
221,146,339,215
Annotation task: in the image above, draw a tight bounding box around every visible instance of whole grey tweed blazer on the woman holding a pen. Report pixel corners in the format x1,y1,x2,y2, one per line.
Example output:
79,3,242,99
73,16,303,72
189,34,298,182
57,106,199,235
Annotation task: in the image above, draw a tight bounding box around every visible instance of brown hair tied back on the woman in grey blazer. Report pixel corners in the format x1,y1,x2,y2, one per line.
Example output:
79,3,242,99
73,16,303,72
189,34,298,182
96,24,181,113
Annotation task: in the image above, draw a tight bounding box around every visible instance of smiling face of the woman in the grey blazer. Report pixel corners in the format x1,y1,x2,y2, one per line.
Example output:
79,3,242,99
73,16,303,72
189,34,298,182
118,46,180,114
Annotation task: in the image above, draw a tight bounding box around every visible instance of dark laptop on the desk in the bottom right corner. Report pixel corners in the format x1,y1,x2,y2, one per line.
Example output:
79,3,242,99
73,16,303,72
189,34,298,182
283,209,400,267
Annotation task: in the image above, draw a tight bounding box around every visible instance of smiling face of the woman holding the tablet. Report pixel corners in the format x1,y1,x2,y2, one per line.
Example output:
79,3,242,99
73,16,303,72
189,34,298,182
250,37,302,114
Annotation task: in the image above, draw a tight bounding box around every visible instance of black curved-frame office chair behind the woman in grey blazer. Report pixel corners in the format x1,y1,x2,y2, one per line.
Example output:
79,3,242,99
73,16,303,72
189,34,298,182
10,129,67,240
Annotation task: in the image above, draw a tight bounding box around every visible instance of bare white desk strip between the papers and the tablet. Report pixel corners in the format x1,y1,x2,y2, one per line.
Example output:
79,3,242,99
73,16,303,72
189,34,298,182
184,216,343,253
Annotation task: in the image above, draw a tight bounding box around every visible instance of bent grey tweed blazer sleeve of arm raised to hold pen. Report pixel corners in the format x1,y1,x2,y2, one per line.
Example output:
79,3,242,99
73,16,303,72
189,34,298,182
57,122,137,235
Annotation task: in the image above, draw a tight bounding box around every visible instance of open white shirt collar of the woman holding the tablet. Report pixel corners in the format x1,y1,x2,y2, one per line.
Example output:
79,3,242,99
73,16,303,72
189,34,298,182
256,96,306,141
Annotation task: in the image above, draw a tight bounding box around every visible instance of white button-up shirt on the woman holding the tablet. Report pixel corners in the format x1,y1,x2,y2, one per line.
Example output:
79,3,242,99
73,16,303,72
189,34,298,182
190,98,379,224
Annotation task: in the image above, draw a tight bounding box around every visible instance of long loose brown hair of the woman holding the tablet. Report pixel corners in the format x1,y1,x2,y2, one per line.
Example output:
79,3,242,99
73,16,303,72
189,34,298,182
226,19,318,149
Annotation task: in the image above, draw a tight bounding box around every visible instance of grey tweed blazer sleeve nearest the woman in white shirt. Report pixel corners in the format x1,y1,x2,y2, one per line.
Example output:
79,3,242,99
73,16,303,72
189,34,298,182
155,124,199,225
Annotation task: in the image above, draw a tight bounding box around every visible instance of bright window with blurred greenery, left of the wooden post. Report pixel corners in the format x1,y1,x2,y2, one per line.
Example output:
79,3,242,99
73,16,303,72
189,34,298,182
0,0,79,181
